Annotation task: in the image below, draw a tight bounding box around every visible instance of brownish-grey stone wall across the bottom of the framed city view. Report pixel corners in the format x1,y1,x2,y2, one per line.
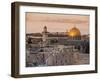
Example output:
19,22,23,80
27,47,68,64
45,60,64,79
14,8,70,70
27,47,80,66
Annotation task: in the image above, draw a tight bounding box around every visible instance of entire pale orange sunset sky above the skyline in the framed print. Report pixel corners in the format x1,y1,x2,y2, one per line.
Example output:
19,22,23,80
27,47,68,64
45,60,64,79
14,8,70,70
26,12,89,34
